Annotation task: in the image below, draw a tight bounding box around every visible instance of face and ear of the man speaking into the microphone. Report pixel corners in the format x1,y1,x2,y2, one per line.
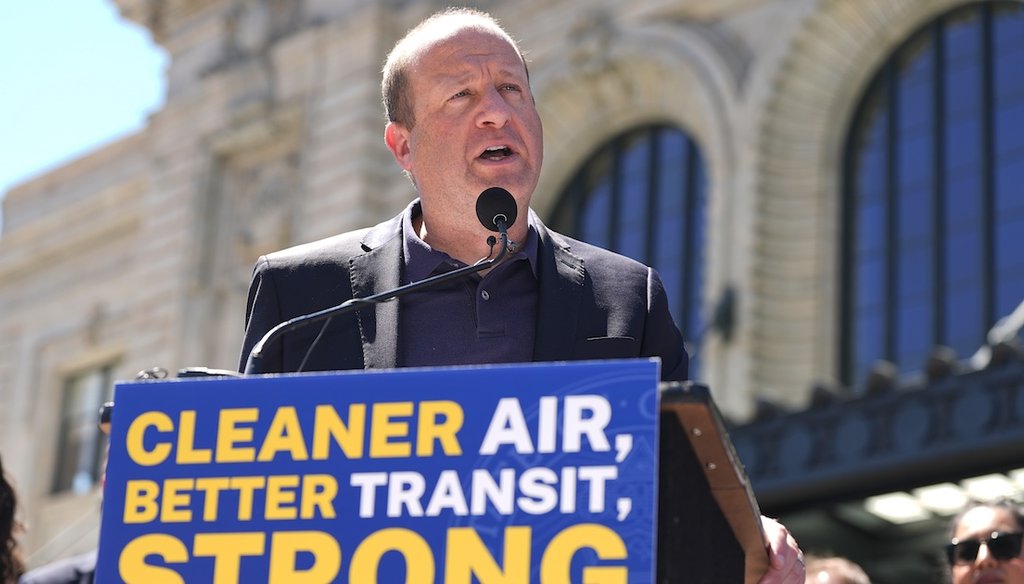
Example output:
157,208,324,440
385,29,544,220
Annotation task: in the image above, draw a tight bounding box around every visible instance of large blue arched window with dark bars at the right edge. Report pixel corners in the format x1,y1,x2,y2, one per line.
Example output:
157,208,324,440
841,2,1024,384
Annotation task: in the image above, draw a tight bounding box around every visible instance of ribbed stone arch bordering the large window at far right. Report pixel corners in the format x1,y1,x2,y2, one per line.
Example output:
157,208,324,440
752,0,1015,401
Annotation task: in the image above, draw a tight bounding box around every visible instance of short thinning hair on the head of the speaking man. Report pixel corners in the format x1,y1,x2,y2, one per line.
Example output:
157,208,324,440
381,8,526,128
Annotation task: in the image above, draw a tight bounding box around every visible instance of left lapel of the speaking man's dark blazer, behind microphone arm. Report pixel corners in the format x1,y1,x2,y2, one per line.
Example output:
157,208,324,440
349,215,402,369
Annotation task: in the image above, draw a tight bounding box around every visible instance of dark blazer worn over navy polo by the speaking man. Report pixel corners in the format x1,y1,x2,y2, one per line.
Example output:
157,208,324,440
240,206,688,380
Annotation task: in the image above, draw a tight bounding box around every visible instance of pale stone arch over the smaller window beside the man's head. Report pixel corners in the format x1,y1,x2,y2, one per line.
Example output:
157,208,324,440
531,18,741,220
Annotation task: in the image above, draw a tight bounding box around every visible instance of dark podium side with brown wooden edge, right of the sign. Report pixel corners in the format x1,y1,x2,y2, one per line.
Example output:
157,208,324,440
657,382,769,584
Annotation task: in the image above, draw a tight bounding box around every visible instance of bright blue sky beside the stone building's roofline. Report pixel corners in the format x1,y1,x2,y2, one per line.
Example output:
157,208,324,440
0,0,167,207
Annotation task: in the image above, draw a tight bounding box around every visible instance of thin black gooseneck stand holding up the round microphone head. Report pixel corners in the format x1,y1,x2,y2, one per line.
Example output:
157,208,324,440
245,224,509,375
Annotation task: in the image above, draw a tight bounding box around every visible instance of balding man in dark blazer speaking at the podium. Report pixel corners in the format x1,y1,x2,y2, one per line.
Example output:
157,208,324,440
241,8,804,584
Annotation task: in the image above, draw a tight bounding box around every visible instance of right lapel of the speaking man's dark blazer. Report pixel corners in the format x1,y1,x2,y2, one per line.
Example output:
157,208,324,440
534,221,586,361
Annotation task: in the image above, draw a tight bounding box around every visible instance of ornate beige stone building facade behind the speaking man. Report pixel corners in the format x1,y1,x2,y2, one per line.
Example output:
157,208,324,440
0,0,1024,565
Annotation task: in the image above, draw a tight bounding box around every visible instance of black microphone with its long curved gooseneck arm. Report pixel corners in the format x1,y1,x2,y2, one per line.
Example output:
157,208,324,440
245,186,518,375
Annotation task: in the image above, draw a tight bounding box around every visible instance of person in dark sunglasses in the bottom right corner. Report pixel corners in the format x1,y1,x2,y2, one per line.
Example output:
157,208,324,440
945,501,1024,584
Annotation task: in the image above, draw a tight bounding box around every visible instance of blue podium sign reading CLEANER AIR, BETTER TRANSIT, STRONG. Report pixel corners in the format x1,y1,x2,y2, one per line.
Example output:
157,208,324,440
97,361,659,584
